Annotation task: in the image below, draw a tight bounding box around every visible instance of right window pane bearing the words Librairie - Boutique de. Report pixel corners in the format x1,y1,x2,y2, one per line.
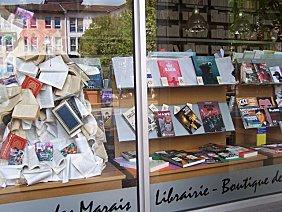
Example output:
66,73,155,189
147,0,282,211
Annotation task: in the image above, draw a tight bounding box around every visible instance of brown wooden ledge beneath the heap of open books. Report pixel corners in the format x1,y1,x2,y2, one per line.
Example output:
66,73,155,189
0,163,125,204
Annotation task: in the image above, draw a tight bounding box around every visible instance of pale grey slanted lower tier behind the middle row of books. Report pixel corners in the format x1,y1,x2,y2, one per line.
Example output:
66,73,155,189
114,102,235,142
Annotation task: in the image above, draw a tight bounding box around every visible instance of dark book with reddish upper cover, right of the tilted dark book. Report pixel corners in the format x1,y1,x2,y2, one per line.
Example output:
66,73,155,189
198,101,226,132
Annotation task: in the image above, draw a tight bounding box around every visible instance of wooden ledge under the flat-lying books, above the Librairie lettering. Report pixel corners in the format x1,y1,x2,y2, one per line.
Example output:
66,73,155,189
115,154,267,183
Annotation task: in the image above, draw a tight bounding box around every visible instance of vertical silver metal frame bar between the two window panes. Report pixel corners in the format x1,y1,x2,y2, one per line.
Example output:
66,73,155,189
133,0,150,212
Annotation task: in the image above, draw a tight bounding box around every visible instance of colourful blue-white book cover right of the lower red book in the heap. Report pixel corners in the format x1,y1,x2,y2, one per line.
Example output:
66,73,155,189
35,142,53,161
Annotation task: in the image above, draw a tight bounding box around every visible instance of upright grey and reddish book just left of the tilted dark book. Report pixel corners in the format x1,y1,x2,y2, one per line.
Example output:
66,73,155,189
155,111,175,137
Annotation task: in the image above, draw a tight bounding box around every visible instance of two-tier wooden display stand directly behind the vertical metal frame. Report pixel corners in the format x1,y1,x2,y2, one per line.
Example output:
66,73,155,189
112,52,267,183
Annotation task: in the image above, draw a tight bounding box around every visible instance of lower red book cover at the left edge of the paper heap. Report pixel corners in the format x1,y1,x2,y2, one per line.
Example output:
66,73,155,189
0,133,27,160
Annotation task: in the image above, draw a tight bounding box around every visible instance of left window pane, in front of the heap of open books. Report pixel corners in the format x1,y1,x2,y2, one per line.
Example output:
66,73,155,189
0,0,138,212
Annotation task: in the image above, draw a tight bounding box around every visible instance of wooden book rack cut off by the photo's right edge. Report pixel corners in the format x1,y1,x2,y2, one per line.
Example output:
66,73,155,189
233,55,282,165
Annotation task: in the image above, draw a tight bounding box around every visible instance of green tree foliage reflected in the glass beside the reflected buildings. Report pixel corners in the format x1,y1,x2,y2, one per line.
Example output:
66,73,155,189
79,0,156,76
